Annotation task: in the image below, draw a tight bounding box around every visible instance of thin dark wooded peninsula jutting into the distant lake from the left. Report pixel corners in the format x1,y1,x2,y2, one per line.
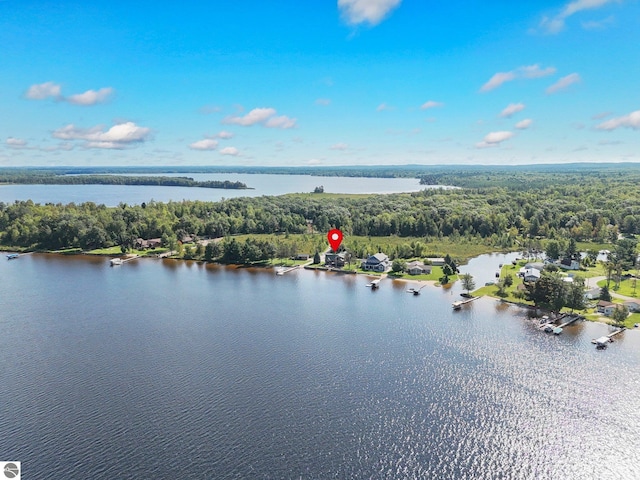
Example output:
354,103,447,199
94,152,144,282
0,170,249,189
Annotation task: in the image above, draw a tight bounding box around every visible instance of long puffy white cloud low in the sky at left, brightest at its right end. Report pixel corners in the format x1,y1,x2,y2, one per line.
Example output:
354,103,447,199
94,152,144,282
53,122,151,149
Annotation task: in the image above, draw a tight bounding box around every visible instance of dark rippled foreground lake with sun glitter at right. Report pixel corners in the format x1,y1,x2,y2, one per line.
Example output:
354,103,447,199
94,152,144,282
0,255,640,479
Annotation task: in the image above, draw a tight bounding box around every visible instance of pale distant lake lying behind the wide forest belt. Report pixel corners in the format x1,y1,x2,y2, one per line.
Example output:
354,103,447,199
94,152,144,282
0,173,427,206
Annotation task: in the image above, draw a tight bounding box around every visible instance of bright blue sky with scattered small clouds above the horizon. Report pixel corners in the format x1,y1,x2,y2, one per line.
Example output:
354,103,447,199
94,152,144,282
0,0,640,166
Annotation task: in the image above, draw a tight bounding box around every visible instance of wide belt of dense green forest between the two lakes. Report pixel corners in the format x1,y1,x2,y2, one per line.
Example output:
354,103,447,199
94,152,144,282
0,173,640,256
